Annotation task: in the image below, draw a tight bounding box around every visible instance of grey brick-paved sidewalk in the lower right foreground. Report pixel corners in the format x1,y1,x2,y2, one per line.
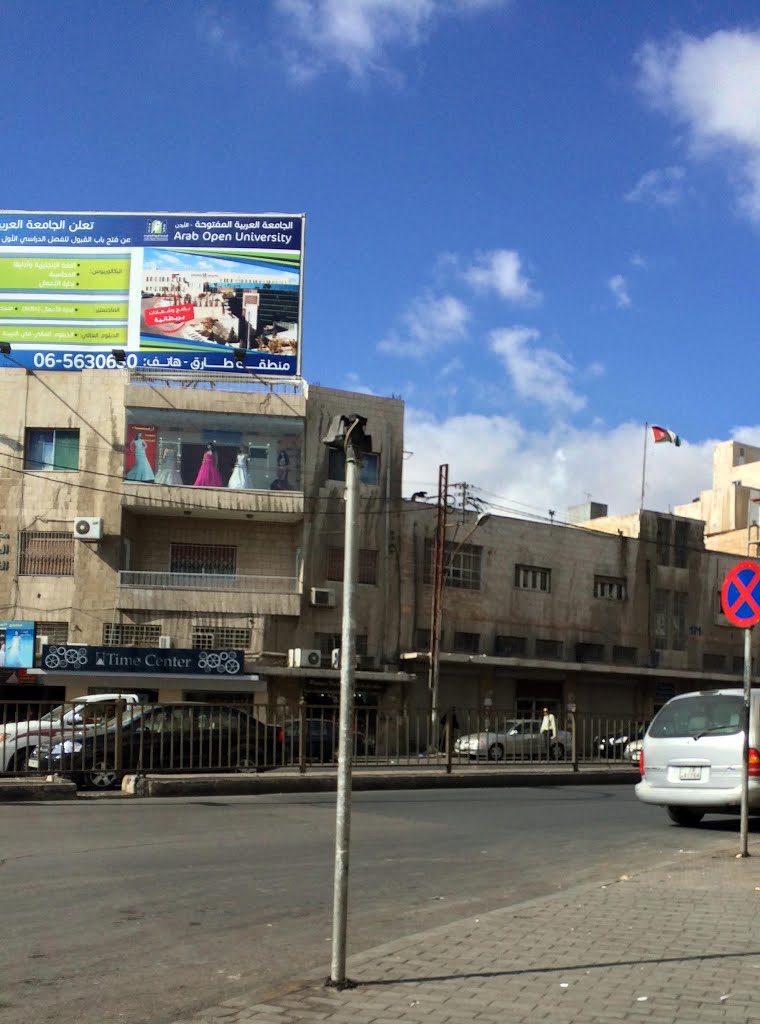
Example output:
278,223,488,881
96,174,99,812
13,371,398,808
181,829,760,1024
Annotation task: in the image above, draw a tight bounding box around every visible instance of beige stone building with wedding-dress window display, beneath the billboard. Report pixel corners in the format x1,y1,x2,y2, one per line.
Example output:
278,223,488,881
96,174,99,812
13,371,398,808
0,369,407,705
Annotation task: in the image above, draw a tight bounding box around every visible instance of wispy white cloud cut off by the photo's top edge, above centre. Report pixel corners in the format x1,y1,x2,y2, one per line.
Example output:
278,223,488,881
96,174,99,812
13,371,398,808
275,0,507,78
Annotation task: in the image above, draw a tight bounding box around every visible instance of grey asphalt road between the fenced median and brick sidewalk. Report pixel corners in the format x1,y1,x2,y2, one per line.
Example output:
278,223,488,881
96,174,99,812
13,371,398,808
0,785,749,1024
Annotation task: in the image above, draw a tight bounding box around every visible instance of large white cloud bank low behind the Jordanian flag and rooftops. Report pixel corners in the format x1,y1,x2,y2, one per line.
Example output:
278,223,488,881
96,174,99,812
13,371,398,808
404,406,721,521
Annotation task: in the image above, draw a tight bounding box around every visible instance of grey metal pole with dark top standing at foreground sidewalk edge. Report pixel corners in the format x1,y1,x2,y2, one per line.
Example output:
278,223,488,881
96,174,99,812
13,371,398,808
328,420,362,988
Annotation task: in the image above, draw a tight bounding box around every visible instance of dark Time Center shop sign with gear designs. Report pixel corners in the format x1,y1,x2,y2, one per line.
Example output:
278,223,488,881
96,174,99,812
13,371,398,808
42,643,244,676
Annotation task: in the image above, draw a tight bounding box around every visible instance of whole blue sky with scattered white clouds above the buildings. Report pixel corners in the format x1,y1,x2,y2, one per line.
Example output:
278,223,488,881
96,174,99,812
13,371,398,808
0,0,760,519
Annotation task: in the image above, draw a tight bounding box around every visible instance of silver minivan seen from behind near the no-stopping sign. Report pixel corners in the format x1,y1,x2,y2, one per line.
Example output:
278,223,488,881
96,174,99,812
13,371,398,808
636,689,760,825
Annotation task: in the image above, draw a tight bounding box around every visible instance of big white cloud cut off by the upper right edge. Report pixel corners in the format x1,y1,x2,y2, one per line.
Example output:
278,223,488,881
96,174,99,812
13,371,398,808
636,29,760,219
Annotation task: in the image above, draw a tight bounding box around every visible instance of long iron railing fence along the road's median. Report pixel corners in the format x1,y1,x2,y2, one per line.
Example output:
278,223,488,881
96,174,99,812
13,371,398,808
0,697,647,788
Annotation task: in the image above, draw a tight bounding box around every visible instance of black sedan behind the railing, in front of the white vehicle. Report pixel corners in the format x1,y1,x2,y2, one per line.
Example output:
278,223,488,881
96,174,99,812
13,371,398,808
29,701,283,790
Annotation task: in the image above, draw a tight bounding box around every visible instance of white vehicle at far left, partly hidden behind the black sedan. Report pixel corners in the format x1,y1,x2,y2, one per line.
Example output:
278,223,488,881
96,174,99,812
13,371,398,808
0,693,140,771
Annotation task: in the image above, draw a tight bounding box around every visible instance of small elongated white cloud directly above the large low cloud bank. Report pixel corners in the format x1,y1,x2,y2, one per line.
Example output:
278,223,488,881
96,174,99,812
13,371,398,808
490,327,586,412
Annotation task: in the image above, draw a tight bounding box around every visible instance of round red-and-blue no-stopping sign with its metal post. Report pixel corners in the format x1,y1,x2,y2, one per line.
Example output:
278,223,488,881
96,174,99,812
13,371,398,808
720,560,760,857
